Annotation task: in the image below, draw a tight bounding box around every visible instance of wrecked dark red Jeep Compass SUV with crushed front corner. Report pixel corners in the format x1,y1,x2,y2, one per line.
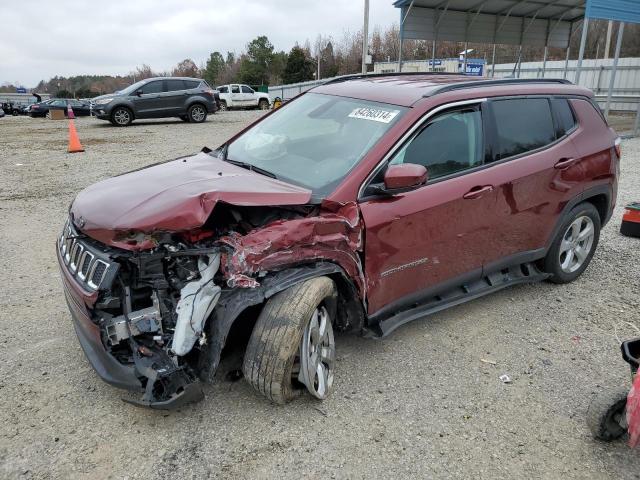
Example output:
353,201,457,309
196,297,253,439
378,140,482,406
57,74,620,408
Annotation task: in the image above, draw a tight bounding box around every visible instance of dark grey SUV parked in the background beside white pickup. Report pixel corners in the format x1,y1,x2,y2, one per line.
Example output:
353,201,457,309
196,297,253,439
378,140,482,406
93,77,218,127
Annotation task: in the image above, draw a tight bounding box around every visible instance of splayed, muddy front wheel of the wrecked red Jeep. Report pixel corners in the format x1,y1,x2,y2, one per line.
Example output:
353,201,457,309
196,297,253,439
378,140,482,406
243,277,337,404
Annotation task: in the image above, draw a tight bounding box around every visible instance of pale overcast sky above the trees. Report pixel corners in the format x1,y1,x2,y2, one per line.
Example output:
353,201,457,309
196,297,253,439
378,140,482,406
0,0,400,87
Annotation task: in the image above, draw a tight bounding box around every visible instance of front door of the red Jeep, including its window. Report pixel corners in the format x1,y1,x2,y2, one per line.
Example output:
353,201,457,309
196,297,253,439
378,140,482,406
360,104,496,315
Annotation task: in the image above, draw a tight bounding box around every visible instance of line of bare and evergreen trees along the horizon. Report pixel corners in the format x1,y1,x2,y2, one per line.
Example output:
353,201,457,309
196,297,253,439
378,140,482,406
0,20,640,98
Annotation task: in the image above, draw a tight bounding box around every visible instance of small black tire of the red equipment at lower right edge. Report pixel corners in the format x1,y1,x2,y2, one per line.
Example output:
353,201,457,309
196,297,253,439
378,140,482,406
587,389,627,442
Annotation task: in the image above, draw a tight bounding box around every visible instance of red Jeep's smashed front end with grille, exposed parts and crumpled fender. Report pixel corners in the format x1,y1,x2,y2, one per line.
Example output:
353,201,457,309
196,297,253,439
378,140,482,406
58,197,364,409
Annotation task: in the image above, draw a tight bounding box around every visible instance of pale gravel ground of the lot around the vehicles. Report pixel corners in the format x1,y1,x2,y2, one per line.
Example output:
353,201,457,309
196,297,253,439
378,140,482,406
0,112,640,479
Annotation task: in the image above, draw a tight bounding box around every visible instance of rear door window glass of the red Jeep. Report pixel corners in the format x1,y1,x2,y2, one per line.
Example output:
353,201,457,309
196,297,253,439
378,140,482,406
491,98,556,160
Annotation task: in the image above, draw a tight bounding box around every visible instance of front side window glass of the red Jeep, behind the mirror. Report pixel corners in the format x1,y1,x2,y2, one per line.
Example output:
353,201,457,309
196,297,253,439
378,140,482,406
391,107,484,180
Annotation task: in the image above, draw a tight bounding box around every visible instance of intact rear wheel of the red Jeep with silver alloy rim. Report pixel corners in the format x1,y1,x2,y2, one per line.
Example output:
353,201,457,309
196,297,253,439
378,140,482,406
543,202,600,283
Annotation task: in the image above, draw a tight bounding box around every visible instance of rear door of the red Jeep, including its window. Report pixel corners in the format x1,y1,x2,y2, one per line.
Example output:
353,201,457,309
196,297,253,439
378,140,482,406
486,96,583,270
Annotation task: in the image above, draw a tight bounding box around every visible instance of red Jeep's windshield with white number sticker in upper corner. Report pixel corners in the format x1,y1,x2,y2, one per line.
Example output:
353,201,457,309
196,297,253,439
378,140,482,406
227,93,406,197
